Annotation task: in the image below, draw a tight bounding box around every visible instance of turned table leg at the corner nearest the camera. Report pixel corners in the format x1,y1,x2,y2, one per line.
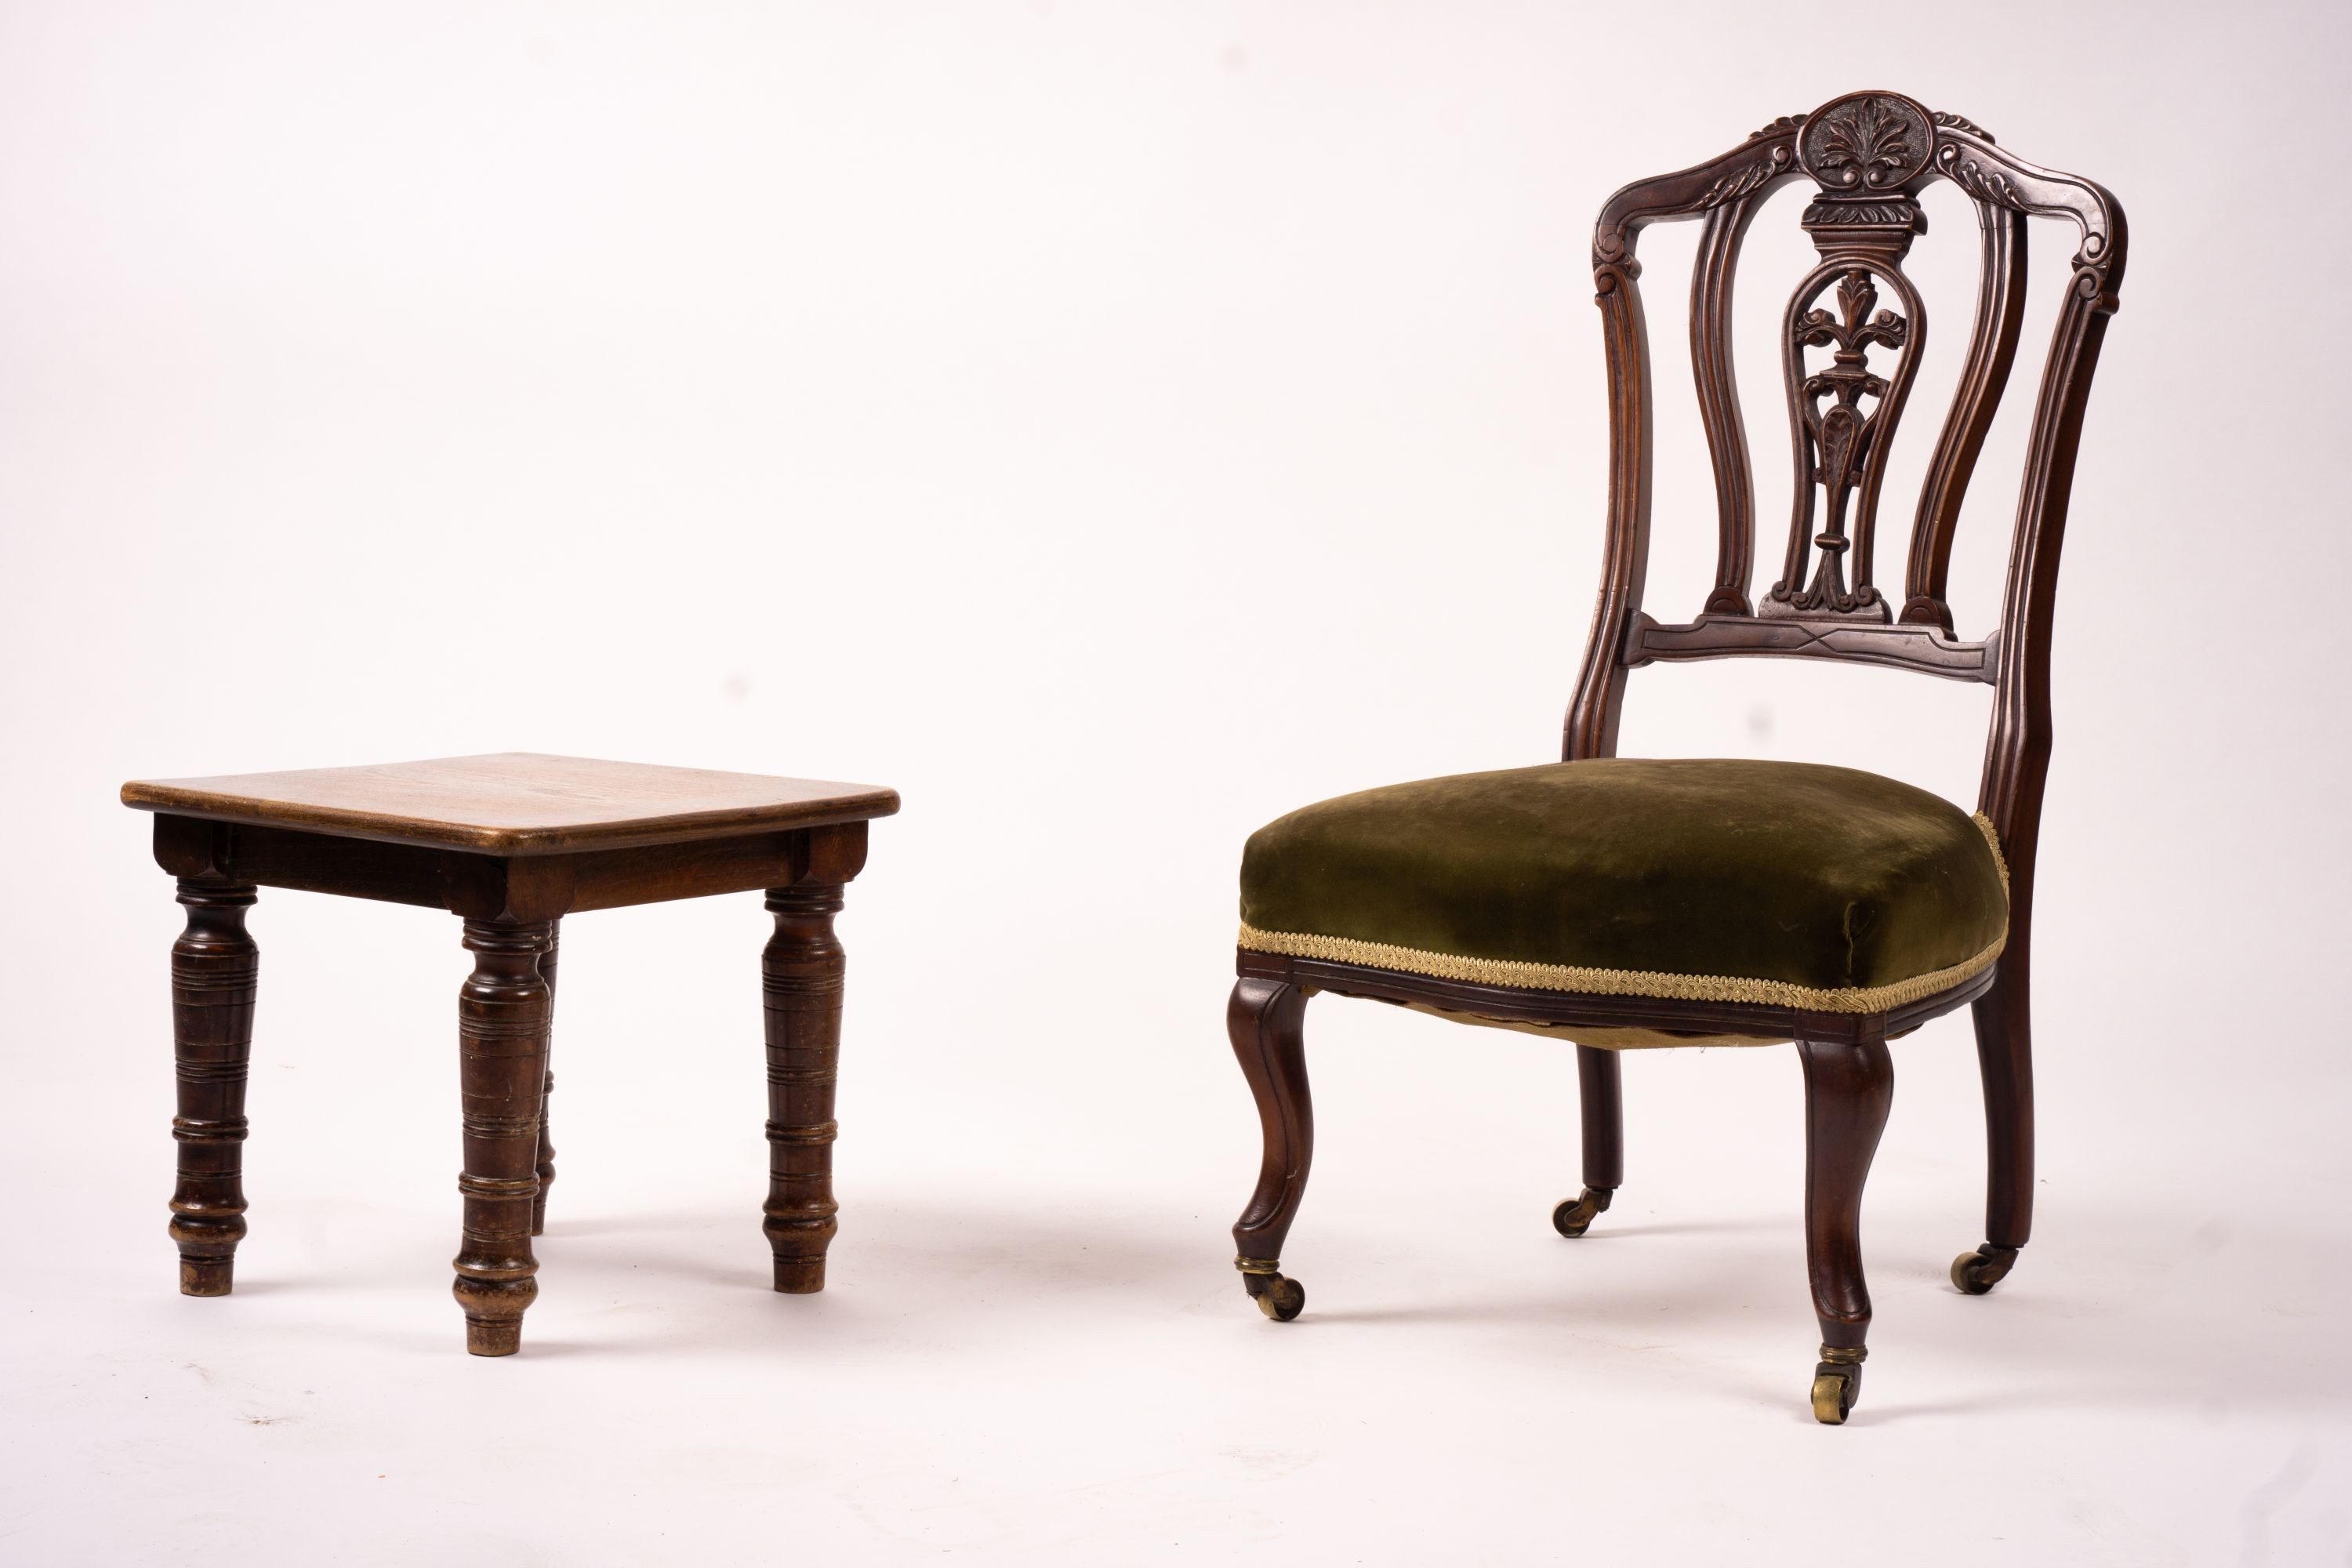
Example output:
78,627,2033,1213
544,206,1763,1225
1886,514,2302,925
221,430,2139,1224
452,919,555,1356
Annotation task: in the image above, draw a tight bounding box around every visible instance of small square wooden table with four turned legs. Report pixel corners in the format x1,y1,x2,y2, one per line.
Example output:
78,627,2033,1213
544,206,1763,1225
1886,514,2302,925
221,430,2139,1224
122,753,898,1356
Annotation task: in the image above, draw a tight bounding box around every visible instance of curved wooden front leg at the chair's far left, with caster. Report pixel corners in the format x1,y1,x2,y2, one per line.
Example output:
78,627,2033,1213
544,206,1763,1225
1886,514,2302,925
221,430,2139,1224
1225,978,1315,1323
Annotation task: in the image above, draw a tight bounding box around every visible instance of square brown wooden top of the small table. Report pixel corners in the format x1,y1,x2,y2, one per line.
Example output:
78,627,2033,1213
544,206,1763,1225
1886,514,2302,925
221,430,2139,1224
122,753,898,855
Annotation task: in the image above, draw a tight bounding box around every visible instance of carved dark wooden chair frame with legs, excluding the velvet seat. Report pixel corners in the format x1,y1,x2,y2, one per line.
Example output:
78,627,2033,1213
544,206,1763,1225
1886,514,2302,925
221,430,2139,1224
1232,92,2126,1420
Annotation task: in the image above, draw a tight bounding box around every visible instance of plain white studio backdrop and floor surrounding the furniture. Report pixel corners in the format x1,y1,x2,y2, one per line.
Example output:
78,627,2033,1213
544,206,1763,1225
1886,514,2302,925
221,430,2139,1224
0,0,2352,1563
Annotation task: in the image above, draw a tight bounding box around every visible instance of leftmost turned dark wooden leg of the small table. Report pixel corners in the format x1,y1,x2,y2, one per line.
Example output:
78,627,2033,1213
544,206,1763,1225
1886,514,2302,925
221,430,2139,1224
172,877,261,1295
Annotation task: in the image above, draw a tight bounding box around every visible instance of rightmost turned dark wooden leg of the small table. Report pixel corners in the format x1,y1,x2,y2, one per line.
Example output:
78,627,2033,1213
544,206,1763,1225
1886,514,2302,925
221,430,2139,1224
760,884,847,1295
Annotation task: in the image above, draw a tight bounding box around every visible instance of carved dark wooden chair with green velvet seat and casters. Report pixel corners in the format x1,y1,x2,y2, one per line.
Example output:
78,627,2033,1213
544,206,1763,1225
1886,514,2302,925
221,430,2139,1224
1228,92,2124,1425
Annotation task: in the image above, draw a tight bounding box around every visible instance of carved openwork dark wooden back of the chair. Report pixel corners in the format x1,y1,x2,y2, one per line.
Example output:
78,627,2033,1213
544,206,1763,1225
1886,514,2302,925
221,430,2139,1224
1564,92,2124,912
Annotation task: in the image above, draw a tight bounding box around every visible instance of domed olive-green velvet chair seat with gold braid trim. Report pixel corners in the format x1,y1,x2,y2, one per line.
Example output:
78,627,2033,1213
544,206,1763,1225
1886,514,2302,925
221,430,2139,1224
1240,760,2009,1025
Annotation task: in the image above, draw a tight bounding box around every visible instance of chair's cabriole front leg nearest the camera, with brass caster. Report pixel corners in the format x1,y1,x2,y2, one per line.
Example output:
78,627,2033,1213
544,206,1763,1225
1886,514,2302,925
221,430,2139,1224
1797,1039,1896,1425
